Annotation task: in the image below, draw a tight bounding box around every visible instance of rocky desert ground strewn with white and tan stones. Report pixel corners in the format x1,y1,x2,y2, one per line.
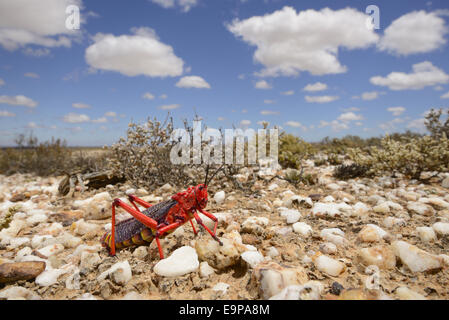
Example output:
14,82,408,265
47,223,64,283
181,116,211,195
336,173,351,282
0,162,449,300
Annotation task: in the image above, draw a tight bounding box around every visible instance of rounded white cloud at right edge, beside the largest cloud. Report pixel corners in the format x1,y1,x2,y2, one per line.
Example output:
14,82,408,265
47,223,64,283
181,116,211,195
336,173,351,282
378,10,448,55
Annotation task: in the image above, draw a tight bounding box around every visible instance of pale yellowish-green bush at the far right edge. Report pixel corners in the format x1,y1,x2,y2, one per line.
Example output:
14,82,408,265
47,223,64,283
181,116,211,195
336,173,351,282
348,133,449,179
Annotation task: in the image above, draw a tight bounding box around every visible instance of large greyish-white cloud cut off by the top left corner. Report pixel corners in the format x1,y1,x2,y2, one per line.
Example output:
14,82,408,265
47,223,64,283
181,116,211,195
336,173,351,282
0,0,85,53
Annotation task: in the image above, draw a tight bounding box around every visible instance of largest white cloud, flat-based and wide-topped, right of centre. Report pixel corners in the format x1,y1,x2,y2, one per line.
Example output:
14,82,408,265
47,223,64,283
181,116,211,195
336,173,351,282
227,7,379,76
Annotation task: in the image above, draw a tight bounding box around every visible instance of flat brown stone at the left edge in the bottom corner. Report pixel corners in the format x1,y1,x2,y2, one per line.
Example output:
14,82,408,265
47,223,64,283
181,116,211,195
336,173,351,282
0,261,46,283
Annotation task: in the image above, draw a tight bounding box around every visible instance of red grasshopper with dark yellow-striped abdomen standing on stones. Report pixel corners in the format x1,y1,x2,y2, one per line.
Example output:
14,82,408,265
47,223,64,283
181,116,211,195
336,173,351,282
101,167,222,259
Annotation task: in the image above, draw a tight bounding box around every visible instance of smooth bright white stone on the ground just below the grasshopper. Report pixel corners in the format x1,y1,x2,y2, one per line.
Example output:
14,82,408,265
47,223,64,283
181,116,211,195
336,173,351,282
154,246,200,277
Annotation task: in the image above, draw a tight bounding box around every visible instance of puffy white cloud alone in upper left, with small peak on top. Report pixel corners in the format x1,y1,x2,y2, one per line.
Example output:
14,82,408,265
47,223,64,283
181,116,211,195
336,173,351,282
85,27,184,77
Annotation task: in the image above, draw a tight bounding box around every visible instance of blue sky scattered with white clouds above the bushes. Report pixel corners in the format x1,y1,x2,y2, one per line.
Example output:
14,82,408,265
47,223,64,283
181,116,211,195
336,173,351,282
0,0,449,146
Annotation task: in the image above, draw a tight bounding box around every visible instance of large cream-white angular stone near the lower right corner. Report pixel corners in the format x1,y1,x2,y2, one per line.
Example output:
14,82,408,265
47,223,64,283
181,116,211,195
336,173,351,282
391,241,442,272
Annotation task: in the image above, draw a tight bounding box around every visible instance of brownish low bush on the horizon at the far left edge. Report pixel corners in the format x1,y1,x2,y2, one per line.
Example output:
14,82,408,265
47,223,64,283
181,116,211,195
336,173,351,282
0,134,105,176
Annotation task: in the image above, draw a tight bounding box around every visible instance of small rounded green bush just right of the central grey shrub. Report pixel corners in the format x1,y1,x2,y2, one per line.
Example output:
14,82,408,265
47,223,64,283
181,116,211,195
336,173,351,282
279,132,315,169
